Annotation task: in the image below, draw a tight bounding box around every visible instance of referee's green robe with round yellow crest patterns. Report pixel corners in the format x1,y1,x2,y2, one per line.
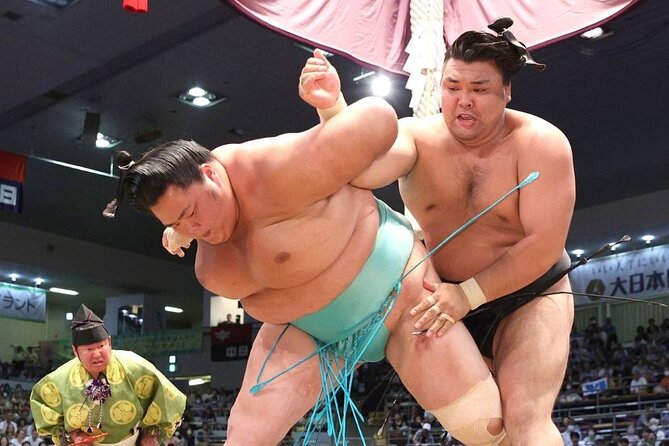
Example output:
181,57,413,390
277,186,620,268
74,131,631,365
30,350,186,446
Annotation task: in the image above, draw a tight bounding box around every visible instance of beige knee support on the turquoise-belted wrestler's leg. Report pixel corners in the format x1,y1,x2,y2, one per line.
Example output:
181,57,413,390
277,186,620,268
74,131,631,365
429,375,506,446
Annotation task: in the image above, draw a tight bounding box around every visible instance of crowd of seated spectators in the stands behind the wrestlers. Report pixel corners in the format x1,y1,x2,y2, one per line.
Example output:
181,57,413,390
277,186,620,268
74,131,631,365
0,318,669,446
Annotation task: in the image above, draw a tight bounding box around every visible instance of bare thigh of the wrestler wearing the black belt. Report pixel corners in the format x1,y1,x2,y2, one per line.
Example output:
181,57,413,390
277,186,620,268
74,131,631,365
493,283,574,414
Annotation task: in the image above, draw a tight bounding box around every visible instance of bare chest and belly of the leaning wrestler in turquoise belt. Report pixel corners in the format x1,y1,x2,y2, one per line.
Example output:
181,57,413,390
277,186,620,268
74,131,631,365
196,188,374,323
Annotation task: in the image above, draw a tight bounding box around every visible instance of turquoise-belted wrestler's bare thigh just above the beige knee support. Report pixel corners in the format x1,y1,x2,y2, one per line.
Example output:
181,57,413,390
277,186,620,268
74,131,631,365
386,280,490,409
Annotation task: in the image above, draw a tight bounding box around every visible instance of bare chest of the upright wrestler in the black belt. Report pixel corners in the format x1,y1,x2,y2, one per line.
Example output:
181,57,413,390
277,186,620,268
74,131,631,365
400,132,522,269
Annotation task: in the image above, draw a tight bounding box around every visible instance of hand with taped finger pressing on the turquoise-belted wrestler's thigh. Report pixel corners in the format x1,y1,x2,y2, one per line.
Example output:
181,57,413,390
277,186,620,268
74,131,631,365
409,280,469,337
